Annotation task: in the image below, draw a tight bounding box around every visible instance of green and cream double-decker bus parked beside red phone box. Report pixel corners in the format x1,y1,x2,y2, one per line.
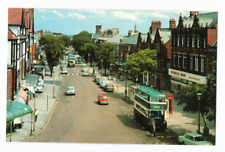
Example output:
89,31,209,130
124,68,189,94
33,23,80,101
134,86,168,131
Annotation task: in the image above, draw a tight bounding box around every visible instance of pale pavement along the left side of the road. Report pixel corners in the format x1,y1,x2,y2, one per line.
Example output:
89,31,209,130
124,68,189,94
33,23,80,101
6,66,61,142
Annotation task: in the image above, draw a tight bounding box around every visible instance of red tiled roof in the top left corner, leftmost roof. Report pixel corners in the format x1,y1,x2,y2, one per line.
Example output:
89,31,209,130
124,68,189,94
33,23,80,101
8,8,23,25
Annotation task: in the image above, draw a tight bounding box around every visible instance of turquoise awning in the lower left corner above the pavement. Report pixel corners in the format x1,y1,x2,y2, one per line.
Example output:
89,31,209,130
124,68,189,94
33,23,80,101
6,100,33,122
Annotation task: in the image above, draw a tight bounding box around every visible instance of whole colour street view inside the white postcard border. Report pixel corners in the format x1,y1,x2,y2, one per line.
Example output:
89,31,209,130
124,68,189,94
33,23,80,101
6,8,218,146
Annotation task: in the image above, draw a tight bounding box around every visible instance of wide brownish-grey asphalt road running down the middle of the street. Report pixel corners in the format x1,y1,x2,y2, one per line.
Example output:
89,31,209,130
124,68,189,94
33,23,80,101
26,66,178,145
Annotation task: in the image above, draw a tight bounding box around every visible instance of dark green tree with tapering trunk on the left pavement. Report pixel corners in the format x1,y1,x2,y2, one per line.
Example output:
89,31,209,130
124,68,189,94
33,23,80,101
40,35,65,76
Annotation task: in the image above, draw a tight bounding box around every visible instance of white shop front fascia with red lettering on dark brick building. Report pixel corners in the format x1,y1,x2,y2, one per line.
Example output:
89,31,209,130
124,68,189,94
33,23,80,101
168,69,207,92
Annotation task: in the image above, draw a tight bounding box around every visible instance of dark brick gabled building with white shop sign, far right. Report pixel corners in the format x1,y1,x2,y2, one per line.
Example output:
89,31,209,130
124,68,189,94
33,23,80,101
169,11,218,92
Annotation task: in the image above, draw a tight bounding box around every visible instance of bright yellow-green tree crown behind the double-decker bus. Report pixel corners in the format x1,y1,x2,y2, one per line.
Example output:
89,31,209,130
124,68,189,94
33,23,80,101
126,49,157,80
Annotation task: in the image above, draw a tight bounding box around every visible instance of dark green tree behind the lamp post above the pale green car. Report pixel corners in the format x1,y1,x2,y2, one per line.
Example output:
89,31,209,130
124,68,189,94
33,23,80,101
174,85,216,127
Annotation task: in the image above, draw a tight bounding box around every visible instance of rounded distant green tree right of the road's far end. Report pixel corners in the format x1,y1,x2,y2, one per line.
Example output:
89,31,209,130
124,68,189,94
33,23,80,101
71,31,91,56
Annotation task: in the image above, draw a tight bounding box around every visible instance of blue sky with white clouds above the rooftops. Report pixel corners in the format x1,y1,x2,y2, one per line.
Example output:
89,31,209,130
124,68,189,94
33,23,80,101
34,8,197,35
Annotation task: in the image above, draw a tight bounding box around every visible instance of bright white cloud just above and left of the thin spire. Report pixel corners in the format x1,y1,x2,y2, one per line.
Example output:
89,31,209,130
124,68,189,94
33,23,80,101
112,11,138,21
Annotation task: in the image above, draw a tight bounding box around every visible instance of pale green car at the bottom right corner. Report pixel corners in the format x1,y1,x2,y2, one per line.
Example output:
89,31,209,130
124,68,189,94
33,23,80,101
178,133,213,146
